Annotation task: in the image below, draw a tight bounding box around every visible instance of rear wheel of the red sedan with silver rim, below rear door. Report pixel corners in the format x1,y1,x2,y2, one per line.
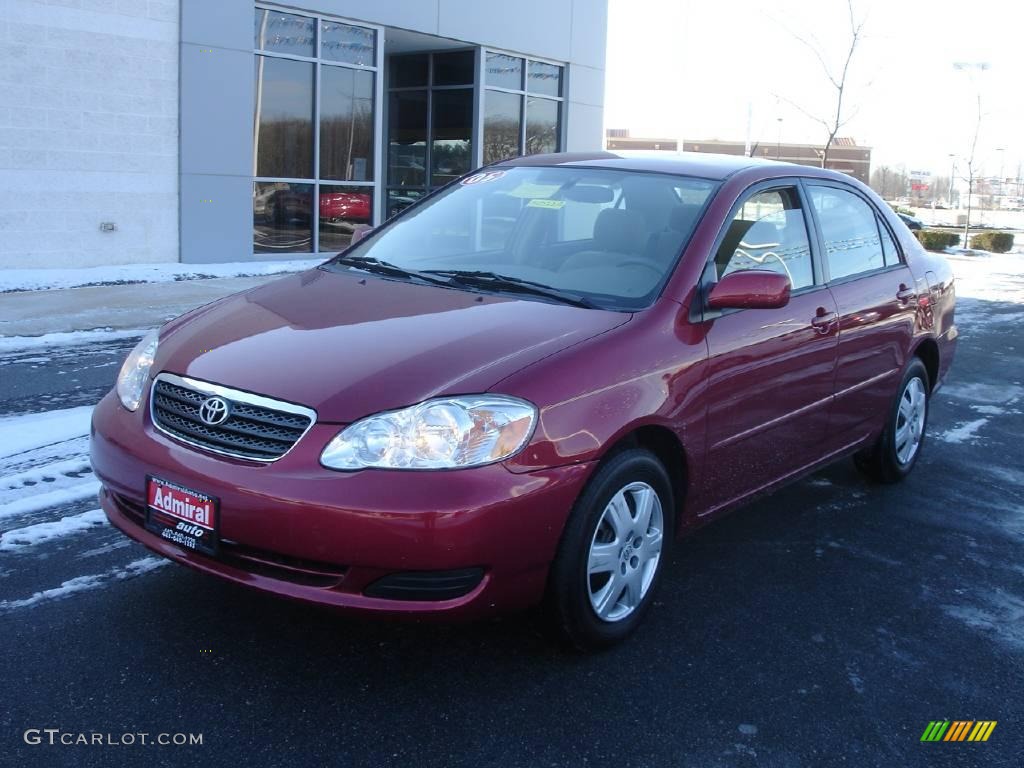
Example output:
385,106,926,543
854,357,931,482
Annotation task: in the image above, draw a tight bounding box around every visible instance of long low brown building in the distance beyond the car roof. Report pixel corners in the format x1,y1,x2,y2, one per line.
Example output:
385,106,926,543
605,128,871,184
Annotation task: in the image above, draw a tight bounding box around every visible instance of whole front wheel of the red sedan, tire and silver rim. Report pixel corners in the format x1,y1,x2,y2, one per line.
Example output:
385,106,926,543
548,449,674,650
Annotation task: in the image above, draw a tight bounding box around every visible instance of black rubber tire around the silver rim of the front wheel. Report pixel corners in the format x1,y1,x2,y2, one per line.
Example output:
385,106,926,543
545,449,675,650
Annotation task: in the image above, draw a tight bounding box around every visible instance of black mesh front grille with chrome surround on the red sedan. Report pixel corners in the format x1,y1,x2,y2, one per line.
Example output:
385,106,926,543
151,374,314,462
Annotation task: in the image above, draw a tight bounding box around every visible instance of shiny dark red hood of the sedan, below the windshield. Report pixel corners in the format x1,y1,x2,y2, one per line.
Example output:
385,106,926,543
153,269,632,423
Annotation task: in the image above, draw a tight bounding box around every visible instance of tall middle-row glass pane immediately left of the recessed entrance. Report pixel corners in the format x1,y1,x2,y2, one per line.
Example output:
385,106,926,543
321,66,374,181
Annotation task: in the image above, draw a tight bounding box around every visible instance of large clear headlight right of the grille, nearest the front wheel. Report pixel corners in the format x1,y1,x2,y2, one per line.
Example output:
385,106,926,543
321,394,537,470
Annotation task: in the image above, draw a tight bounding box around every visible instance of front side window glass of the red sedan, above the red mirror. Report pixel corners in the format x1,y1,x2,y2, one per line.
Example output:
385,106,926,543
715,187,814,291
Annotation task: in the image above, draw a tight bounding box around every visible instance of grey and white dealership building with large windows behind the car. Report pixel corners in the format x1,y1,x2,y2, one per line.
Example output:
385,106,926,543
0,0,607,267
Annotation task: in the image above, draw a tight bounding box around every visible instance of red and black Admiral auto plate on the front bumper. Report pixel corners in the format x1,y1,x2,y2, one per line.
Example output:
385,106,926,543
145,475,220,555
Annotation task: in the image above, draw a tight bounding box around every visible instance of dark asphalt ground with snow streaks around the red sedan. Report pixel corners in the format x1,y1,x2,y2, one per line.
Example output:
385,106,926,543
0,274,1024,768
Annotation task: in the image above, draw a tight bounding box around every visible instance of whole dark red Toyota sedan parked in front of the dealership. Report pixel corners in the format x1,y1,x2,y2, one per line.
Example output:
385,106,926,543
92,153,956,648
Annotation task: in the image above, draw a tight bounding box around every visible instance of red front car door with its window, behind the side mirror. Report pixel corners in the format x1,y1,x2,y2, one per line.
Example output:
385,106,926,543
699,185,838,512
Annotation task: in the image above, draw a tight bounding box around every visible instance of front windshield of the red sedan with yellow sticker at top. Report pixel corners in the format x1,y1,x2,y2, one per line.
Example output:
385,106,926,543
323,167,715,310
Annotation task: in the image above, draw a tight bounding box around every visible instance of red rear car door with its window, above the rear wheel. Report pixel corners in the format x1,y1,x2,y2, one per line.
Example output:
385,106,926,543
806,181,918,443
